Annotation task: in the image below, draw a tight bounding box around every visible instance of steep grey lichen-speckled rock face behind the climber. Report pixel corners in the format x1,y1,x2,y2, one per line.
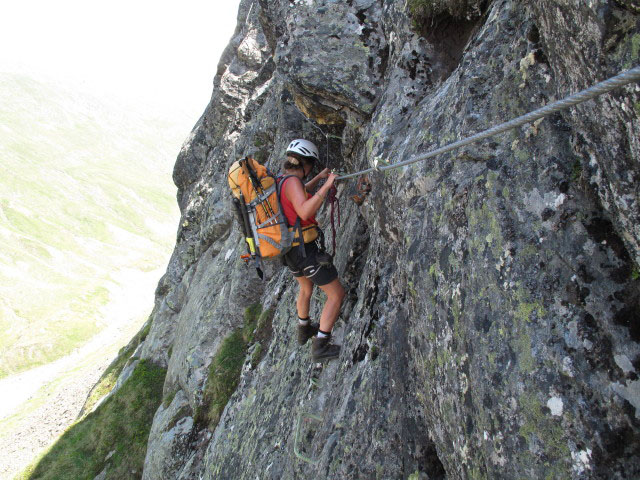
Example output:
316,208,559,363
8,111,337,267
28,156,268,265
131,0,640,480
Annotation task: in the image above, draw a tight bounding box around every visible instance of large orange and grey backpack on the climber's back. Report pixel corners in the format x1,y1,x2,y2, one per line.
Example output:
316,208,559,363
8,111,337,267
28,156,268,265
228,157,318,258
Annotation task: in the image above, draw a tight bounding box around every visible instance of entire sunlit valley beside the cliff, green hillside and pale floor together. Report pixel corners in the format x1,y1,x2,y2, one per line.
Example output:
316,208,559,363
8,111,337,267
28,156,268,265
0,71,185,479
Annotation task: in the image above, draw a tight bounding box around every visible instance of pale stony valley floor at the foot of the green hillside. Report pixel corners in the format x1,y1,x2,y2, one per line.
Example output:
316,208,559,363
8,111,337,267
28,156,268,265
0,269,163,479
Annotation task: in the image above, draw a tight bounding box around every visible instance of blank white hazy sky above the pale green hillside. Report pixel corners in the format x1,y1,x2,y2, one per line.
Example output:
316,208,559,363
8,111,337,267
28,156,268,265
0,0,239,114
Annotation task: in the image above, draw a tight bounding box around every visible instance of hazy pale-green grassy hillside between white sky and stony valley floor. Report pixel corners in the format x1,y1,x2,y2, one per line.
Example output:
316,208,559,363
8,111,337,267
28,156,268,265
0,73,188,378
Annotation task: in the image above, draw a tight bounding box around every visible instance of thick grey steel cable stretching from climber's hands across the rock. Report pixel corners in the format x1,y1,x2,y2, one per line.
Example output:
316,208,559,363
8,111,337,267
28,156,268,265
337,67,640,180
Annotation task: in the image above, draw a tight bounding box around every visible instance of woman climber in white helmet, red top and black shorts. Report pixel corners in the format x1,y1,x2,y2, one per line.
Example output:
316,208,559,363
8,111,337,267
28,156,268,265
279,139,345,361
